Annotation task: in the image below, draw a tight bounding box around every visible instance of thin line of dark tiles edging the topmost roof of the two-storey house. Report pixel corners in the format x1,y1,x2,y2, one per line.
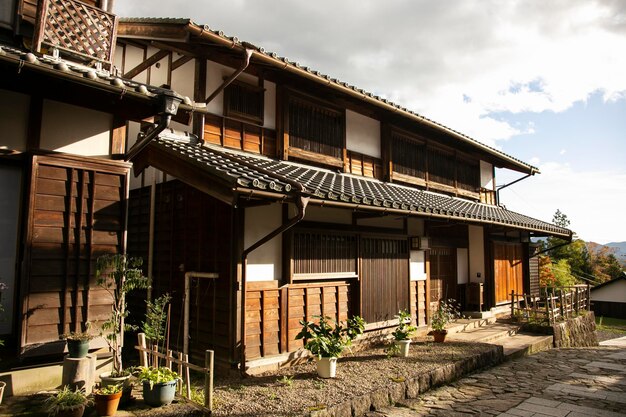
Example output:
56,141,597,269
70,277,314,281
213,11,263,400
120,17,539,172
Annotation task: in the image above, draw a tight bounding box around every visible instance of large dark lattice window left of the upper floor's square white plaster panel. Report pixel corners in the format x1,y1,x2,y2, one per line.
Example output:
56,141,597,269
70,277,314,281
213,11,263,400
287,96,345,159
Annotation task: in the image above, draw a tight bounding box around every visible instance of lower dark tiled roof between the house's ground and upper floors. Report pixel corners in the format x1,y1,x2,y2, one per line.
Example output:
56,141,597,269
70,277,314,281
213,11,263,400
150,135,571,237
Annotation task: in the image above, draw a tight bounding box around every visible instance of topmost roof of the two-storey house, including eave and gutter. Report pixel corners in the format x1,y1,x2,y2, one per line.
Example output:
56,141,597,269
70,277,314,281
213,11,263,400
119,17,539,174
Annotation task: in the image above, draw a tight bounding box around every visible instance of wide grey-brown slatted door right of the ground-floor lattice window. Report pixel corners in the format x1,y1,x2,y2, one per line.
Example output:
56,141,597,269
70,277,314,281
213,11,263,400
361,237,409,323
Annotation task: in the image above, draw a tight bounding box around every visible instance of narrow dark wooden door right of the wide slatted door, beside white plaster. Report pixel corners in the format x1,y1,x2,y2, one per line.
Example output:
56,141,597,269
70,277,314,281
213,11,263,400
430,247,457,302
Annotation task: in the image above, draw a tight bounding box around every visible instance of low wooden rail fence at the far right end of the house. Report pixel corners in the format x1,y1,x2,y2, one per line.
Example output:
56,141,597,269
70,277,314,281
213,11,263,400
511,284,591,325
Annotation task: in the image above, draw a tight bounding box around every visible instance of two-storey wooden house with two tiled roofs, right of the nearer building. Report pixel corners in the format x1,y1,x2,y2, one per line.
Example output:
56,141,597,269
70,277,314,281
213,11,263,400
115,18,571,369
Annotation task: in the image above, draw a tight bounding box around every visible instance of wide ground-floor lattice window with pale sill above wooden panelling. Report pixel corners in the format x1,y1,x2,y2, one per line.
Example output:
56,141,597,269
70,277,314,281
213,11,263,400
293,231,357,280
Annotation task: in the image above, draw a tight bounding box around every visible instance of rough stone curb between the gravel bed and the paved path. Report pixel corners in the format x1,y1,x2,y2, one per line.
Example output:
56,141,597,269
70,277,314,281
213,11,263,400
305,345,505,417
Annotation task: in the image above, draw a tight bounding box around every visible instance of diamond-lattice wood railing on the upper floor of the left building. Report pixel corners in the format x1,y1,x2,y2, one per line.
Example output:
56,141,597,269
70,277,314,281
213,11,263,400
33,0,117,65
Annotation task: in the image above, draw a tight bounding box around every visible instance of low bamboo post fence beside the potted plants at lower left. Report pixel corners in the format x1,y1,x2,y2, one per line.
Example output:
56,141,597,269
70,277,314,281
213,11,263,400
135,333,215,411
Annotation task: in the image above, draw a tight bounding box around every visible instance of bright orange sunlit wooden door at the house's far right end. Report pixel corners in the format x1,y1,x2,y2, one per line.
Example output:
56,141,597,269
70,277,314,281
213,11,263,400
493,243,524,304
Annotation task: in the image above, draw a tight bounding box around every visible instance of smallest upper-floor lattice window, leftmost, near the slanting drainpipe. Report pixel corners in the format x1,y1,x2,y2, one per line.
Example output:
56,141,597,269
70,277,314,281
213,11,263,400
224,81,264,125
